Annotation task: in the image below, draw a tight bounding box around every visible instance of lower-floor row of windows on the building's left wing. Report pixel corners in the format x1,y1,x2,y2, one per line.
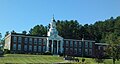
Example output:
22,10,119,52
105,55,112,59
13,44,46,52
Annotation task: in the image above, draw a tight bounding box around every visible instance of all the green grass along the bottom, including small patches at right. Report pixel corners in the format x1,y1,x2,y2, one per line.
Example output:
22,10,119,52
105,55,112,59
0,54,120,64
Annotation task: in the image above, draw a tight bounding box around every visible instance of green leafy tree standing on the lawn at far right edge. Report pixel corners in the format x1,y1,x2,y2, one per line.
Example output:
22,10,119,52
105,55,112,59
106,33,120,64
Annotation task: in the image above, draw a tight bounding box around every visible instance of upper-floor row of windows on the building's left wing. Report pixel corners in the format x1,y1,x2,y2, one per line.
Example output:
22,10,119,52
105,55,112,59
13,36,46,44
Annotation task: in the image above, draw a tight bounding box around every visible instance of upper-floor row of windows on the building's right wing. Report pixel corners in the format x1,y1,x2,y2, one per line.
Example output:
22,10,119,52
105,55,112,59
66,41,92,48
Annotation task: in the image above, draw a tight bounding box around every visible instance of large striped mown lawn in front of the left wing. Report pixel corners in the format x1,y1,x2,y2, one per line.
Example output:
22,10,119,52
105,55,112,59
0,54,64,64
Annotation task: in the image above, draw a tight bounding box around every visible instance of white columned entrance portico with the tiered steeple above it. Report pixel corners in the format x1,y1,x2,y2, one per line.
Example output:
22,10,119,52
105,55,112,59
47,17,63,54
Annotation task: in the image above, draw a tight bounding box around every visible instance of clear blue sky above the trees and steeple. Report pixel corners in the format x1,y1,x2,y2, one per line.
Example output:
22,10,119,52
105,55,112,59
0,0,120,37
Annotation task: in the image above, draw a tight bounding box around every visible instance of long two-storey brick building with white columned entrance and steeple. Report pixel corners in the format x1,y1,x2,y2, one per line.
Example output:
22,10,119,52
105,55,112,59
4,18,95,57
